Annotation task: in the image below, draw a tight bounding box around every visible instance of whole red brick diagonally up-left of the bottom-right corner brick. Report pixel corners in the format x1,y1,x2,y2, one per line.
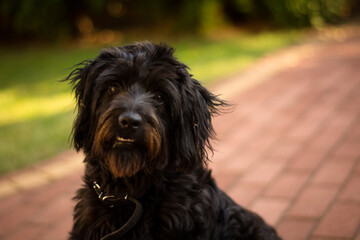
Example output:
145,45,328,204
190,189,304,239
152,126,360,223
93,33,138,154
289,186,337,218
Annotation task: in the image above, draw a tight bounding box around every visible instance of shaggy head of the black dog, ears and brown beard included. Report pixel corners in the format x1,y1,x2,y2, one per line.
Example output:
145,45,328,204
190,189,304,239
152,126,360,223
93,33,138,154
67,42,223,178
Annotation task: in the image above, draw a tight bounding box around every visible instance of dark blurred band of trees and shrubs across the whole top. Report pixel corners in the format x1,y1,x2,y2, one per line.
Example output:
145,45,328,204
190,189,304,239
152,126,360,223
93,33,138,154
0,0,360,41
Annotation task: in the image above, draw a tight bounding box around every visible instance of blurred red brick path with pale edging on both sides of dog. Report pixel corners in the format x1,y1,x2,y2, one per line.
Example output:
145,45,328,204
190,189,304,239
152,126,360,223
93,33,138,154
0,27,360,240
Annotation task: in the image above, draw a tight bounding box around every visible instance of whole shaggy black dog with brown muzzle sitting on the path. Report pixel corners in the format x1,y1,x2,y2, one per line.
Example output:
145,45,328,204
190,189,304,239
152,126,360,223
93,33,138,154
67,42,280,240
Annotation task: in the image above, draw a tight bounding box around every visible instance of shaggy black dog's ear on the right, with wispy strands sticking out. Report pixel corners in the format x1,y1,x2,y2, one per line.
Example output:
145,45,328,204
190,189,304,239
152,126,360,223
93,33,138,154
176,73,227,170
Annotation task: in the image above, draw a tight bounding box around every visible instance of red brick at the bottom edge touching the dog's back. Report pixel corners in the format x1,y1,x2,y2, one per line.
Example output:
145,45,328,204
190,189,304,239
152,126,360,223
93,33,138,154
277,218,316,240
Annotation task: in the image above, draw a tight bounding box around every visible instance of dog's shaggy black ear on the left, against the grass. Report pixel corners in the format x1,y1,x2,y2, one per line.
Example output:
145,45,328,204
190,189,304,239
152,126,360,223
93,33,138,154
65,61,93,152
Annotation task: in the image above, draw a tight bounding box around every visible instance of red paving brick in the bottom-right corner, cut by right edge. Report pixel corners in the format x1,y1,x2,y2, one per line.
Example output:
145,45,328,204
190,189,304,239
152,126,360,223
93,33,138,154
314,204,360,238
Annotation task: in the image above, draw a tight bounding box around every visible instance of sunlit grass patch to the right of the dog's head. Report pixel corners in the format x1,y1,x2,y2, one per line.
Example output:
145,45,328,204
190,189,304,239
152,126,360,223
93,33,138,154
175,32,299,84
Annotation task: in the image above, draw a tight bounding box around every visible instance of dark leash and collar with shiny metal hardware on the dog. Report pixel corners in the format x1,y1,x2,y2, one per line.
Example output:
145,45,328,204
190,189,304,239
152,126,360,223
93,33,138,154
93,181,143,240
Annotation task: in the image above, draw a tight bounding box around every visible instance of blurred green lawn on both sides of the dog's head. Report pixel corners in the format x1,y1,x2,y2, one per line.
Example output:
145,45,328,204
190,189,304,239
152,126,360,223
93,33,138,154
0,32,300,174
